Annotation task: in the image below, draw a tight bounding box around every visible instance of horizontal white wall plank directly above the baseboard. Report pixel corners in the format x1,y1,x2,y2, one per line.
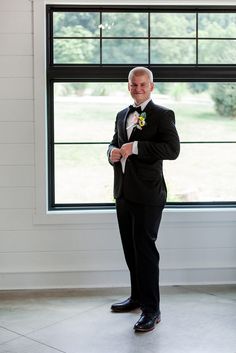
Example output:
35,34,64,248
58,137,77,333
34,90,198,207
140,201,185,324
0,248,236,272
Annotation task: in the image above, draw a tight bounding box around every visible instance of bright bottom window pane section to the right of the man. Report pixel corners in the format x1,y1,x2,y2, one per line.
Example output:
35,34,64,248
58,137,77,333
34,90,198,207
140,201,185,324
164,144,236,202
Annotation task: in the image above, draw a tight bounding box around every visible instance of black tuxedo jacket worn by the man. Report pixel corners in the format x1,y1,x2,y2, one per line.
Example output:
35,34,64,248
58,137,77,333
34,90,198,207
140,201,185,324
108,101,180,206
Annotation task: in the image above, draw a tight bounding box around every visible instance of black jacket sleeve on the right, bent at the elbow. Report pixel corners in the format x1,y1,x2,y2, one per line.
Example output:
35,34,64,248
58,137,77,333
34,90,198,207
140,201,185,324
138,110,180,161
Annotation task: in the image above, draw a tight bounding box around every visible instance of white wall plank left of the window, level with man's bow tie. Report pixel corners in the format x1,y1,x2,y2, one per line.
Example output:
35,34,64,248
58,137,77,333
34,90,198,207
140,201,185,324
0,99,34,122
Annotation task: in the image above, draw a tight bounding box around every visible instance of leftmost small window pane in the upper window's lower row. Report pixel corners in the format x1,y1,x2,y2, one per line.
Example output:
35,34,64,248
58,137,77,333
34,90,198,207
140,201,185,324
54,39,100,64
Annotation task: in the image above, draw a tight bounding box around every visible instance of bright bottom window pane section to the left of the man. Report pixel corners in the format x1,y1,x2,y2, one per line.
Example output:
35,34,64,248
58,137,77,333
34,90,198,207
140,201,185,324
55,145,114,204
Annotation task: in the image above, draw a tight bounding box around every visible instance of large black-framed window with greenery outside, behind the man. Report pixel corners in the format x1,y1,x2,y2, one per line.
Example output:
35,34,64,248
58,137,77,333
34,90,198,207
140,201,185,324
47,6,236,209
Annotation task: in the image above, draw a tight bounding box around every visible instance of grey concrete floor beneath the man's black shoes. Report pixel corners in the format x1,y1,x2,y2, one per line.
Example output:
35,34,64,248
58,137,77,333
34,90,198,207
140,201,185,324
0,285,236,353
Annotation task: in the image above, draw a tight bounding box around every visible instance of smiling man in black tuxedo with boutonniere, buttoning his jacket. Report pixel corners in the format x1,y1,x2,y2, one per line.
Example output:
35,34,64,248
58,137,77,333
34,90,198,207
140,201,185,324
108,67,180,332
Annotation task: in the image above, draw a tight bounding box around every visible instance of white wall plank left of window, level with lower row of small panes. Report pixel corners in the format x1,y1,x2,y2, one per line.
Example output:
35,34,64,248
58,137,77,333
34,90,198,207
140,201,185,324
0,33,33,55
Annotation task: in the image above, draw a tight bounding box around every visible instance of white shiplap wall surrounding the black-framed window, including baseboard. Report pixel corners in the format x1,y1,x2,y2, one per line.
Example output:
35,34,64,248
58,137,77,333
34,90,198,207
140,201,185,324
0,0,236,289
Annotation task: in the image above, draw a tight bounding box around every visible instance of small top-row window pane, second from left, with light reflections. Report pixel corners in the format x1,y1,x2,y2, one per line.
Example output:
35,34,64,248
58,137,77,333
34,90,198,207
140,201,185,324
101,13,148,37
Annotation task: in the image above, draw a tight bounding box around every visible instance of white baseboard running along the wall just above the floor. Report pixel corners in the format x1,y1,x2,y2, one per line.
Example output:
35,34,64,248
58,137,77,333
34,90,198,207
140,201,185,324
0,267,236,290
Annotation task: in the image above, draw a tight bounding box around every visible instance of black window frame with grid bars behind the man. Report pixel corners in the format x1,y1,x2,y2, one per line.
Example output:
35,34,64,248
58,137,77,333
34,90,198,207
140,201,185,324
46,5,236,210
